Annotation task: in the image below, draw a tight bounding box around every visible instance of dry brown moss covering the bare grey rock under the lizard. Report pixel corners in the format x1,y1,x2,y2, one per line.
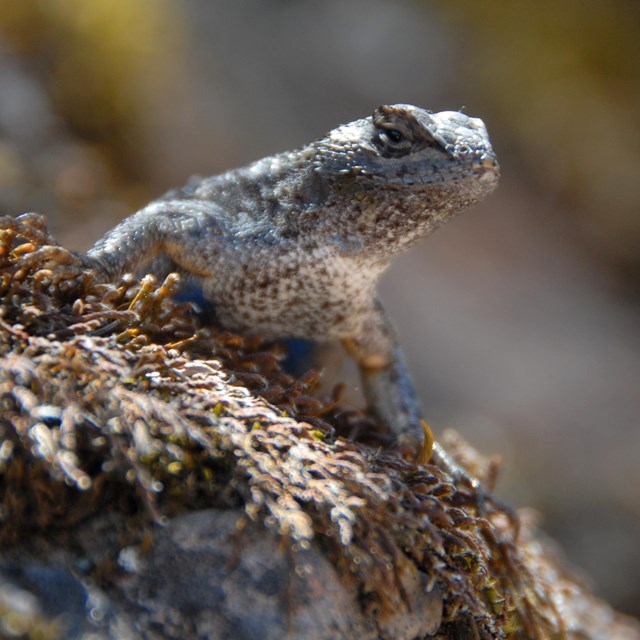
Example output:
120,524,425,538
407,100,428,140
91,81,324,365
0,215,635,638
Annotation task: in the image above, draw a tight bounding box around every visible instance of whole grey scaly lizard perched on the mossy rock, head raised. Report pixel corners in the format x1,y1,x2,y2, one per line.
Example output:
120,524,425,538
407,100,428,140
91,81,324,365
86,104,499,458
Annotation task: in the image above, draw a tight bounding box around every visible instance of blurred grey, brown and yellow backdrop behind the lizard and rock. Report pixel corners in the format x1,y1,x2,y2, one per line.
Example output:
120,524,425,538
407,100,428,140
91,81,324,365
0,0,640,615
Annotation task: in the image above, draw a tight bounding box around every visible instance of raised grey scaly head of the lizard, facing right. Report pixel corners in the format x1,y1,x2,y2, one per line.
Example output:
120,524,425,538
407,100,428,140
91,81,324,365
316,104,499,244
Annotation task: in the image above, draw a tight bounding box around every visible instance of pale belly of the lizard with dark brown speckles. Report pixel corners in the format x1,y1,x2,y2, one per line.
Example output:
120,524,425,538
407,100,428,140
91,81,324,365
204,249,376,340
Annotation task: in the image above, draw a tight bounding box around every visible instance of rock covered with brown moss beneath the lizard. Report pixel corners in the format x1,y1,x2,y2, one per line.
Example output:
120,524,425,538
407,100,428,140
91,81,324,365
0,214,640,639
